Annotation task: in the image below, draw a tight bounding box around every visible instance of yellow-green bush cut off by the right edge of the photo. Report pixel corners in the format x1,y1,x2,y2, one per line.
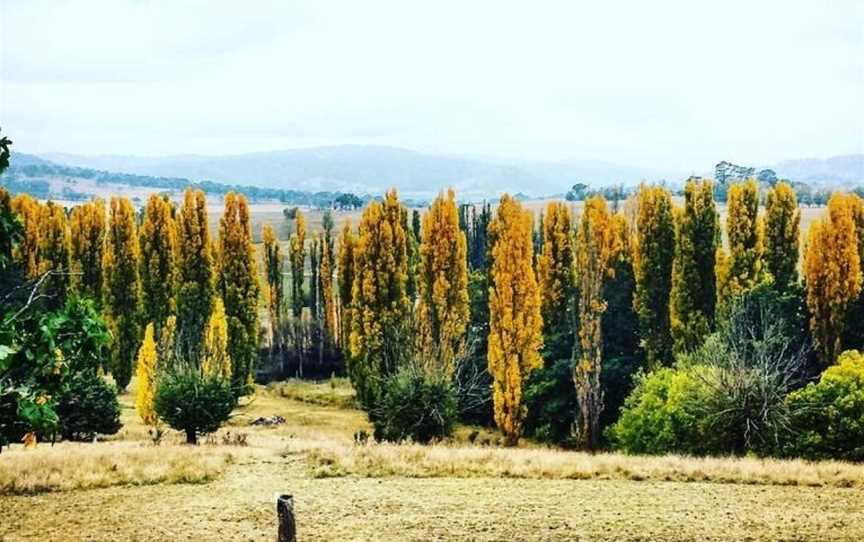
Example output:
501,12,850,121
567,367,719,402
781,350,864,461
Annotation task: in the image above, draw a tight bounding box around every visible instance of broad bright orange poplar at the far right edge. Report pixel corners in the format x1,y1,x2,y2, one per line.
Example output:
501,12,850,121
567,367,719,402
804,194,861,365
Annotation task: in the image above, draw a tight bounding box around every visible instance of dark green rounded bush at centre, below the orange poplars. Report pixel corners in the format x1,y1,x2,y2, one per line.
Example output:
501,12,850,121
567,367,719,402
370,367,458,443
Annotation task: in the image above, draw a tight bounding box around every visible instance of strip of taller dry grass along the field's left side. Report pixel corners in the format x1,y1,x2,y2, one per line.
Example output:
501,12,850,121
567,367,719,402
0,442,233,495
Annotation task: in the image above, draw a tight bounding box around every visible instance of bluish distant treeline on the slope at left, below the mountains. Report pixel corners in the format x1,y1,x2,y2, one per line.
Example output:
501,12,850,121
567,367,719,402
0,163,371,209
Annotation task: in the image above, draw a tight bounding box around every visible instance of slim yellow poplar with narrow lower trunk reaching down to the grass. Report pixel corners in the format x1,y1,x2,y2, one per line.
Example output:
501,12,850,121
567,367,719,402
573,196,622,450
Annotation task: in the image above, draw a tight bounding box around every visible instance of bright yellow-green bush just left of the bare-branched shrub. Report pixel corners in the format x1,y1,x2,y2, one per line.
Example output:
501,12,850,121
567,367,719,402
607,367,708,454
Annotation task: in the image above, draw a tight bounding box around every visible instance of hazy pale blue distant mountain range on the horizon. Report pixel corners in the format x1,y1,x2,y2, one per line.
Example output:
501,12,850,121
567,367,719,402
43,145,684,198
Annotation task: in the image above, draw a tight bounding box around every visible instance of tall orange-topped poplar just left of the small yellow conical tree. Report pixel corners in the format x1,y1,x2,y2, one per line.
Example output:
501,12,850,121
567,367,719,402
103,197,141,390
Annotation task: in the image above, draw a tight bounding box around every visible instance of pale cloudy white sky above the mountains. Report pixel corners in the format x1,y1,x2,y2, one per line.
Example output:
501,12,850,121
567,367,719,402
0,0,864,170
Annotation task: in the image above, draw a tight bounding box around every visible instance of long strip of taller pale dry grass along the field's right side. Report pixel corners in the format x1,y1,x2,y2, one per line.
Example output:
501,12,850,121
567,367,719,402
285,440,864,488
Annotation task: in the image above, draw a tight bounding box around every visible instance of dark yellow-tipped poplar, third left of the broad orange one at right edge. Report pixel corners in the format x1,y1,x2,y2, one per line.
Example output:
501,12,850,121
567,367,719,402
670,180,720,353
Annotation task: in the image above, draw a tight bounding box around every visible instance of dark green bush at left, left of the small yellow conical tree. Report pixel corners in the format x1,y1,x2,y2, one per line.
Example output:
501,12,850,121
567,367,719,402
57,371,122,441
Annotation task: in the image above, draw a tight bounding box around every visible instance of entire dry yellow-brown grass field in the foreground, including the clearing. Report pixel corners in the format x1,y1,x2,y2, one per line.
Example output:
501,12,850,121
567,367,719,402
0,380,864,541
